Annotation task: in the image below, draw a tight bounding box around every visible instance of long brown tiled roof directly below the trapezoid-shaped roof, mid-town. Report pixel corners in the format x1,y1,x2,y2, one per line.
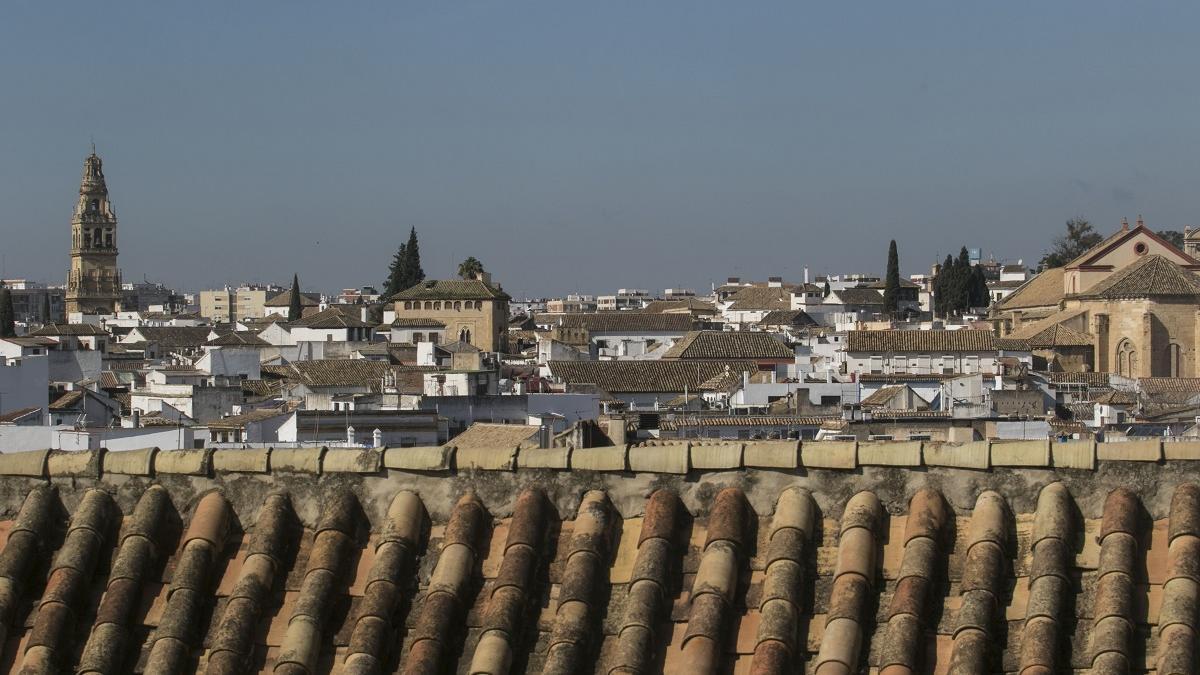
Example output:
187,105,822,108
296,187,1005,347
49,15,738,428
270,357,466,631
548,360,757,394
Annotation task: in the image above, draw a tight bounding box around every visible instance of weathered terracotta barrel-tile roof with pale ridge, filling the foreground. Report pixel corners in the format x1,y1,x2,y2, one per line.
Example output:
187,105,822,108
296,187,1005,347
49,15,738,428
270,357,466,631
0,442,1200,675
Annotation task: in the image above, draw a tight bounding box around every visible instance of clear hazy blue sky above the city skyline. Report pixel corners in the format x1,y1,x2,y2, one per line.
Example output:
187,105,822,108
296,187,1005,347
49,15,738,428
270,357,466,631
0,0,1200,294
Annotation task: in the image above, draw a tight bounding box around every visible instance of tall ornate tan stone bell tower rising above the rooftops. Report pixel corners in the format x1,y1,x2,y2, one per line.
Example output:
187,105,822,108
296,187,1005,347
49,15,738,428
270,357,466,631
66,147,121,315
